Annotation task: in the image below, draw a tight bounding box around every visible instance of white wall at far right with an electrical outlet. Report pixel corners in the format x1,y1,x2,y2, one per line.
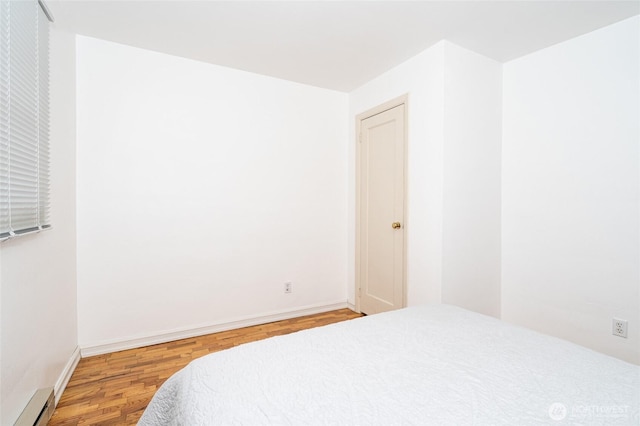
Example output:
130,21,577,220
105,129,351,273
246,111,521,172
502,17,640,363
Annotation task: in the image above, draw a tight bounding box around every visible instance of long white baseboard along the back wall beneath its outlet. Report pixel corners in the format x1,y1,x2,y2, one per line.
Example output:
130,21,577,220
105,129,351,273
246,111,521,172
84,302,347,358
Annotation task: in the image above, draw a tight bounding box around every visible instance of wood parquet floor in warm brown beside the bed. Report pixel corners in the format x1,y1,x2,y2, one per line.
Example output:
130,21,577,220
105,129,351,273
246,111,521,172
49,309,361,426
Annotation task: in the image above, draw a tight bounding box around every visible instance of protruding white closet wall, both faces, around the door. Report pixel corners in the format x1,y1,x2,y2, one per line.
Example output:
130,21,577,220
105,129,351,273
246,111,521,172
348,41,502,316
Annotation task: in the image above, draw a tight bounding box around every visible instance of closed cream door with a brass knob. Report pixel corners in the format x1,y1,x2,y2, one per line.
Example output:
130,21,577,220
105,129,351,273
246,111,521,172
356,99,405,314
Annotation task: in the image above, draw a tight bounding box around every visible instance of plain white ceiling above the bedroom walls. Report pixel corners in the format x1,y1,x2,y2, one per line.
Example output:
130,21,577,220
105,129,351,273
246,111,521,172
47,0,640,92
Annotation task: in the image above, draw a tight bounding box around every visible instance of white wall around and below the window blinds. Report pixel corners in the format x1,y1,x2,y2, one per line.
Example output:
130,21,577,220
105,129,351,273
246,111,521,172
0,27,77,425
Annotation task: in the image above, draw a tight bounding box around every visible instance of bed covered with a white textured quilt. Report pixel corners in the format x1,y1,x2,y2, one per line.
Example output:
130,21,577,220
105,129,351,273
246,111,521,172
139,305,640,426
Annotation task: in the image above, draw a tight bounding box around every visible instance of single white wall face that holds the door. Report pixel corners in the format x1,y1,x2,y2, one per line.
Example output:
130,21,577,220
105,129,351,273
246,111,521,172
348,42,445,305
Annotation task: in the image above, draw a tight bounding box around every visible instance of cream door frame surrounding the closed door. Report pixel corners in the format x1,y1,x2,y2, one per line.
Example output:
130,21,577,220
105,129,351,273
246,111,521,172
355,93,409,313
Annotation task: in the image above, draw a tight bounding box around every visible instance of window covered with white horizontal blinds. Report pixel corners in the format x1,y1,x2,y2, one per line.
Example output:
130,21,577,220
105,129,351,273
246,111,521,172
0,0,51,241
